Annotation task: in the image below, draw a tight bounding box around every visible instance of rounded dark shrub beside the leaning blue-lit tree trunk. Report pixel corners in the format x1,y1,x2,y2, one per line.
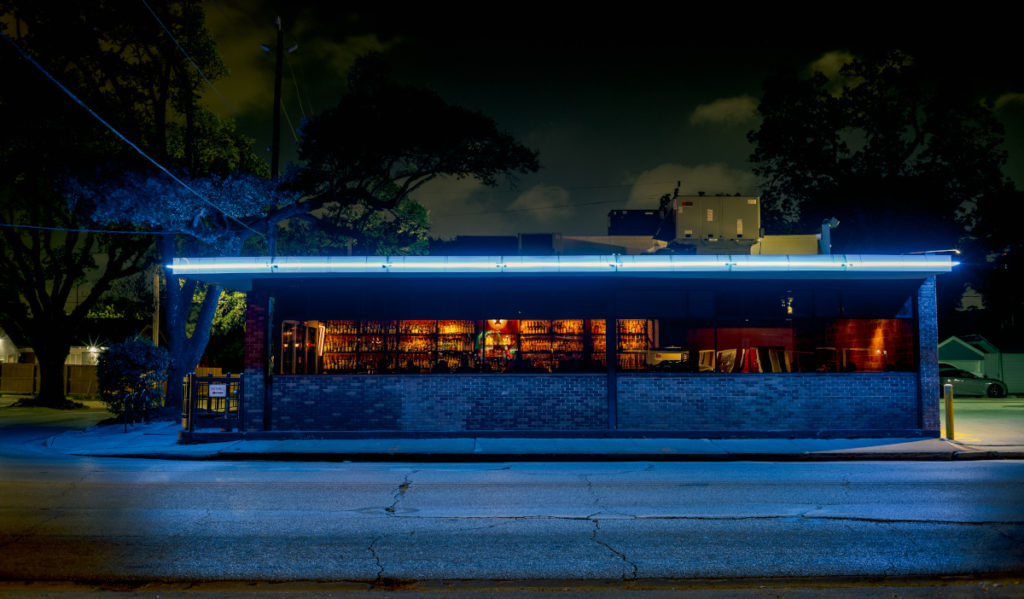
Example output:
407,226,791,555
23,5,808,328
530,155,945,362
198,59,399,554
96,335,171,424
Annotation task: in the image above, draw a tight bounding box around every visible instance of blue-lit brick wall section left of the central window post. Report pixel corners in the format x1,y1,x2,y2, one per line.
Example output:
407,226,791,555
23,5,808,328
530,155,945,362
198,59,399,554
272,374,608,431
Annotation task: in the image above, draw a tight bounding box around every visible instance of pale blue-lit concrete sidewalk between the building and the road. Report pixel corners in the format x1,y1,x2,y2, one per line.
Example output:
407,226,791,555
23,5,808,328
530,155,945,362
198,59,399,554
37,422,1024,462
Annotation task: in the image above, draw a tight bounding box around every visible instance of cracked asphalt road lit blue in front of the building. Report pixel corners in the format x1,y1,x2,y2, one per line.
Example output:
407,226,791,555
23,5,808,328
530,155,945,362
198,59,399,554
0,456,1024,584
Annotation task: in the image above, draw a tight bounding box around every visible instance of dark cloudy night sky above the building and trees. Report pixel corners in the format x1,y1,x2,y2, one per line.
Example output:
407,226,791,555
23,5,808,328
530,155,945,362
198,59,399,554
206,0,1024,238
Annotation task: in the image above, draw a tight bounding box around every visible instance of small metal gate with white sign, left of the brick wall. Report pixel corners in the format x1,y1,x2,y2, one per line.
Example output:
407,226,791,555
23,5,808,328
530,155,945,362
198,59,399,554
181,373,244,432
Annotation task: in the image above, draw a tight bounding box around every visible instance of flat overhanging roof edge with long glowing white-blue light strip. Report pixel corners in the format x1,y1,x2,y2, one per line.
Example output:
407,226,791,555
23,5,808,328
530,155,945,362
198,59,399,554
167,254,957,290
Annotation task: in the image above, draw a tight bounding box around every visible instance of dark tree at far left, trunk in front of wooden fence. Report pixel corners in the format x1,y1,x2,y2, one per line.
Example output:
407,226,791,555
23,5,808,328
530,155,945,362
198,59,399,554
0,1,178,407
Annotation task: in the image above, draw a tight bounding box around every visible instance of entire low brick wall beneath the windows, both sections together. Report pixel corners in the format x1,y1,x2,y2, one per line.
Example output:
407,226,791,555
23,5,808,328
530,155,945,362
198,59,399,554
262,373,918,434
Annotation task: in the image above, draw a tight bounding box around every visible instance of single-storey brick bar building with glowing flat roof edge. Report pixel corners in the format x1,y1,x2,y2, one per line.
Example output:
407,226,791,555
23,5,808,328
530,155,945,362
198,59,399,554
170,249,954,437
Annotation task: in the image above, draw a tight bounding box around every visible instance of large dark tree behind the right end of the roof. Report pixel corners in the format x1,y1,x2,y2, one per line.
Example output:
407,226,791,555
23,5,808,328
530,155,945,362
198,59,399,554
749,47,1006,252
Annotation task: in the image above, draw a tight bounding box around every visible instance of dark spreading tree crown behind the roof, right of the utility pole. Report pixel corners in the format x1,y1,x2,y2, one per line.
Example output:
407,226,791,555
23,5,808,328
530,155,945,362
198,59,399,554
288,55,539,216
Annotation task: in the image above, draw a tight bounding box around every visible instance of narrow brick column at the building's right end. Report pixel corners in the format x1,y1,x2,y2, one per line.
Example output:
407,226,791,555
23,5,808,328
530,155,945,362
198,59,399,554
914,276,940,433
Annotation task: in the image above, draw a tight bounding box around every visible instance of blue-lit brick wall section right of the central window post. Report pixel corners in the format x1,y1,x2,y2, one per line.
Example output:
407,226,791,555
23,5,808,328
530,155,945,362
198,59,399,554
618,373,918,431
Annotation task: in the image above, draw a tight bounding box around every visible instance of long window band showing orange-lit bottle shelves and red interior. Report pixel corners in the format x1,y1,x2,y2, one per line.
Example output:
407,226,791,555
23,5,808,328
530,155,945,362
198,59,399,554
278,285,916,374
